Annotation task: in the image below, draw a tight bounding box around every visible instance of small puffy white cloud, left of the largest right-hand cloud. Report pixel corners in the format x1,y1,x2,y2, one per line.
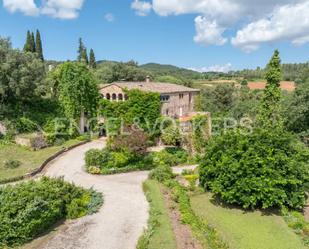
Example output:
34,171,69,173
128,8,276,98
194,16,227,46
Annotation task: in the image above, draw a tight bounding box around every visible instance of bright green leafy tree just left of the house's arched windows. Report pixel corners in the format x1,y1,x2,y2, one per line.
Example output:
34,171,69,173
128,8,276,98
52,62,99,119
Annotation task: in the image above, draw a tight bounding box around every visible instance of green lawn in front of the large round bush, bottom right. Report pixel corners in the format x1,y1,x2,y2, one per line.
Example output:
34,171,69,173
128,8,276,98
191,194,307,249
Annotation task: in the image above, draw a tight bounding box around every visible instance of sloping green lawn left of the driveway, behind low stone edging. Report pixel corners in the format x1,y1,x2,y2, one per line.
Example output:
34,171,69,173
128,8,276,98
0,140,81,180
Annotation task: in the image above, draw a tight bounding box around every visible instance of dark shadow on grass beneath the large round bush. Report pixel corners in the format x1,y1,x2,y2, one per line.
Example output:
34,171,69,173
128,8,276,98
206,192,281,216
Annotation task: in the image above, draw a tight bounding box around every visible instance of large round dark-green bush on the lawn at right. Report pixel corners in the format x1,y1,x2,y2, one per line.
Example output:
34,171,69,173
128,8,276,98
200,129,309,209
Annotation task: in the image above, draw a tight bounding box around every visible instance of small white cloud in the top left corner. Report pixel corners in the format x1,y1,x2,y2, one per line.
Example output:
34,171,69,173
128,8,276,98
3,0,39,16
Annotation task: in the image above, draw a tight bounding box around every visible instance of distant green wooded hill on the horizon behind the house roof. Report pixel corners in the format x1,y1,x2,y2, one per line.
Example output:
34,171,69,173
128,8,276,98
139,63,202,80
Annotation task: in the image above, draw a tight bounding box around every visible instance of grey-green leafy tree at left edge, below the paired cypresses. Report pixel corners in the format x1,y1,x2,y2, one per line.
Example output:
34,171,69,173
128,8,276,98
0,39,45,105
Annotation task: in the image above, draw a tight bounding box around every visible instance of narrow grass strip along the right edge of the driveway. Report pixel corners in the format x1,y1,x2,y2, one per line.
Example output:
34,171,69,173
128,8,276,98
137,180,176,249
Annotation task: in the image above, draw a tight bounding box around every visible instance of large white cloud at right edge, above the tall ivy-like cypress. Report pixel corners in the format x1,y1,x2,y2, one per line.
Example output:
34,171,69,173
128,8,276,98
232,1,309,52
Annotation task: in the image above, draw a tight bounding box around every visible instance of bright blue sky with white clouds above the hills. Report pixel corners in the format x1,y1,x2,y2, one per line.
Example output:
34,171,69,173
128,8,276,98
0,0,309,70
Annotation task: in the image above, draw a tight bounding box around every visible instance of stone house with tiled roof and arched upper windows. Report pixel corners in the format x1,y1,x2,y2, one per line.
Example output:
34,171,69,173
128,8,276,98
99,80,200,118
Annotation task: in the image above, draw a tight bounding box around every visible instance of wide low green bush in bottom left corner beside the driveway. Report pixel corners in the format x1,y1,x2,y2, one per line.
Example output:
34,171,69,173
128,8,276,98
0,178,102,248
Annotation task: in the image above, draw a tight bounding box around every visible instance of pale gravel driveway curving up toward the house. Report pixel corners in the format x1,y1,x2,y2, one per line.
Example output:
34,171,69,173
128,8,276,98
39,140,148,249
